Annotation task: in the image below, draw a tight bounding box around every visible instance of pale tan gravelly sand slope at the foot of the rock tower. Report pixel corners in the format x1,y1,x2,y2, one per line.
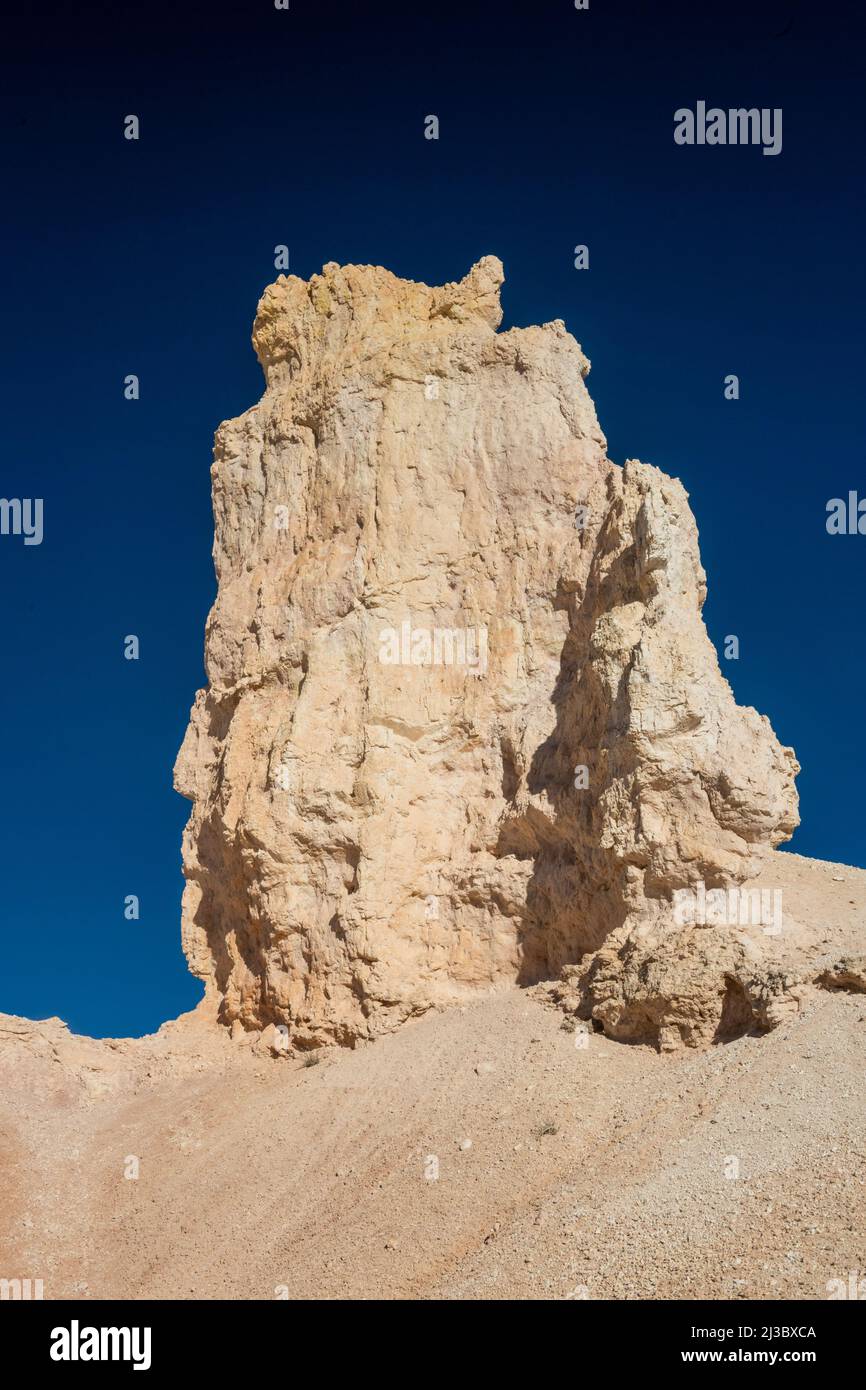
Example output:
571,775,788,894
0,855,866,1300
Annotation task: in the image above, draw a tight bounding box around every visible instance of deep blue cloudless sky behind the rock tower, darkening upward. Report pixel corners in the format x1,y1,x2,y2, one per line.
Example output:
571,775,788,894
0,0,866,1036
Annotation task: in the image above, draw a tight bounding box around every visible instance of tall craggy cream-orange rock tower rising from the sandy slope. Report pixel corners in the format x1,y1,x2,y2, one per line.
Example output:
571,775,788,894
175,257,798,1047
